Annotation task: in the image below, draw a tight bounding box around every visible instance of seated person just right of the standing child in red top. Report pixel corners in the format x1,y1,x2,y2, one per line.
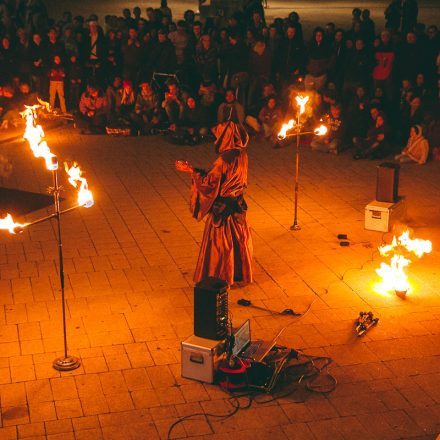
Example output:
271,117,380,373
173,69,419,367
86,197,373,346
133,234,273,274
75,83,108,134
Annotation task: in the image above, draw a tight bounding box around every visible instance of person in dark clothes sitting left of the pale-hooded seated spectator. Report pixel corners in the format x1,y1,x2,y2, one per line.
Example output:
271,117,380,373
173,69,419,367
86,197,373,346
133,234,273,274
353,112,390,160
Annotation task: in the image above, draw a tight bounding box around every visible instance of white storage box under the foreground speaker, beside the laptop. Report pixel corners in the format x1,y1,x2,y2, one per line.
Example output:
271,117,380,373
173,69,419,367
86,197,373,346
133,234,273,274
181,335,225,383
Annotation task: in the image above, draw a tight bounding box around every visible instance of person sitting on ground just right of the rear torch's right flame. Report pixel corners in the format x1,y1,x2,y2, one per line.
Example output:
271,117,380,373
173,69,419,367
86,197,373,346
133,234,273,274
310,104,345,154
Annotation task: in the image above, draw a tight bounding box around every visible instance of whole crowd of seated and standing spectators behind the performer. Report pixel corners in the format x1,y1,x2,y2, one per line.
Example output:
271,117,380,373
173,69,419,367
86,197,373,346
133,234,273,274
0,0,440,164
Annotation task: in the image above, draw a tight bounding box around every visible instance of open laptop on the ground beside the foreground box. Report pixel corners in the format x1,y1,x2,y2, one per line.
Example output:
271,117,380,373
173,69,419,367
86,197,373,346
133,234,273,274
232,319,276,362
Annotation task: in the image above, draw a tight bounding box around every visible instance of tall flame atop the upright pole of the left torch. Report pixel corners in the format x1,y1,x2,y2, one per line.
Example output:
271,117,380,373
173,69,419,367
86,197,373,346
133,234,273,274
21,101,58,170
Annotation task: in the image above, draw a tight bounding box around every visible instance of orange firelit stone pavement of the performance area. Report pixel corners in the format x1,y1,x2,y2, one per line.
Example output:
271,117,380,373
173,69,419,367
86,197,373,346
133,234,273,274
0,128,440,440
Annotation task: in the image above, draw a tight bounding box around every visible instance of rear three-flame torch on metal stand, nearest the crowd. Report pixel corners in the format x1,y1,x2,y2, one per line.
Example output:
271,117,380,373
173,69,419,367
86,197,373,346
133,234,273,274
278,95,327,231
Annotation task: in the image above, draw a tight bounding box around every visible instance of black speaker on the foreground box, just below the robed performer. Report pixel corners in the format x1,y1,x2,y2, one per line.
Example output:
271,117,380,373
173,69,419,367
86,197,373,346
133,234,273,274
194,277,228,340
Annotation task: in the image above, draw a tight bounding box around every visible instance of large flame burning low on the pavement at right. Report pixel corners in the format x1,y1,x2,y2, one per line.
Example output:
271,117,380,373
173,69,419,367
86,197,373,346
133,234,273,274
376,230,432,292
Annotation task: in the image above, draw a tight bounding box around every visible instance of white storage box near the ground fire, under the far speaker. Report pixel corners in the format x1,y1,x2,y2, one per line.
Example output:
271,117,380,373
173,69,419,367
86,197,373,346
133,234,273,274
365,198,406,232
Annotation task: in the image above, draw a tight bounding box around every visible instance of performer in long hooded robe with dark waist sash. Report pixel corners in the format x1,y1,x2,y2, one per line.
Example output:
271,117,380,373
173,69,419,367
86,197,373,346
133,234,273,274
176,121,252,287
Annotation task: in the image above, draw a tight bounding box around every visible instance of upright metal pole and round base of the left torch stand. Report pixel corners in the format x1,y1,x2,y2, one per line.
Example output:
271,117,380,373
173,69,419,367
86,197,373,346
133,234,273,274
50,167,81,371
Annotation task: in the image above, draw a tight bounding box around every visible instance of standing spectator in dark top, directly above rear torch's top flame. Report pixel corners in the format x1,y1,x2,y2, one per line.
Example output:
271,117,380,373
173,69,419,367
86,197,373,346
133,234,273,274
305,27,331,90
